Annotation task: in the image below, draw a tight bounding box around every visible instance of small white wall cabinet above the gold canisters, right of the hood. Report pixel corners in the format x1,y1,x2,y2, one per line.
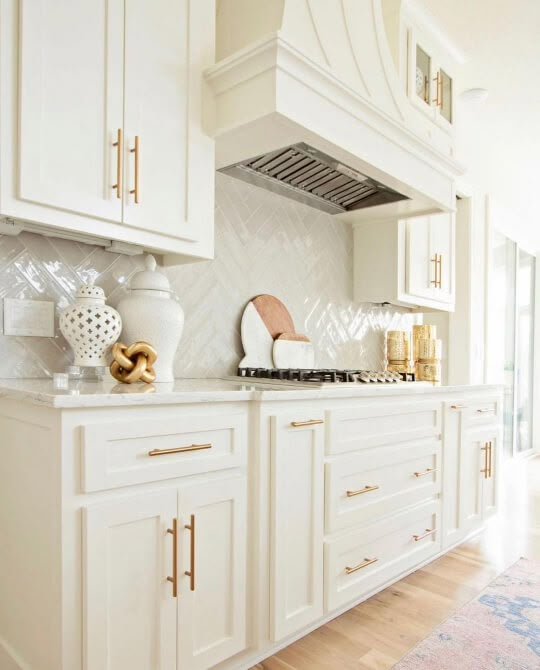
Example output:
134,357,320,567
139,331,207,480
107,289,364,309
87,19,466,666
354,214,456,311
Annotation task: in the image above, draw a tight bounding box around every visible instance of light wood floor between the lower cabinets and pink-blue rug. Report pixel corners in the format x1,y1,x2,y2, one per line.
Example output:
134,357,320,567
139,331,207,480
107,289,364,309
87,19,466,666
254,457,540,670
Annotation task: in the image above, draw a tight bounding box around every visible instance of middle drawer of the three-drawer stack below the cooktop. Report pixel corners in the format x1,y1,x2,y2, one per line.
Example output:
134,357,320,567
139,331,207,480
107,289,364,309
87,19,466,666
326,440,441,533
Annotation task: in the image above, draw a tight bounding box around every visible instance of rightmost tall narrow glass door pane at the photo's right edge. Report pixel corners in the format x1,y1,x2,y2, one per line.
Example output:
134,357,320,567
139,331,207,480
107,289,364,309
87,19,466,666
516,250,535,453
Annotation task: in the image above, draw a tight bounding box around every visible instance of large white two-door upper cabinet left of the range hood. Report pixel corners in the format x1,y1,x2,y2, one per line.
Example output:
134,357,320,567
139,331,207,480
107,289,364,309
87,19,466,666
0,0,215,258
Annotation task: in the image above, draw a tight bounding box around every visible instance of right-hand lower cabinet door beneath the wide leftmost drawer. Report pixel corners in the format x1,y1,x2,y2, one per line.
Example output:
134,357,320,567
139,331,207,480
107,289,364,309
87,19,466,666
178,476,247,670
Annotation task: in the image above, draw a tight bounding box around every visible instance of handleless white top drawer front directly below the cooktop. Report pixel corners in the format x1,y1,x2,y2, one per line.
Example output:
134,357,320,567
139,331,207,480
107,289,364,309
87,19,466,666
326,398,442,454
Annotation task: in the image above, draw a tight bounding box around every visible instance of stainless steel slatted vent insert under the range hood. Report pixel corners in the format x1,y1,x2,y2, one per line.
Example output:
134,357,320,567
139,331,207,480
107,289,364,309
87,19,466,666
219,143,408,214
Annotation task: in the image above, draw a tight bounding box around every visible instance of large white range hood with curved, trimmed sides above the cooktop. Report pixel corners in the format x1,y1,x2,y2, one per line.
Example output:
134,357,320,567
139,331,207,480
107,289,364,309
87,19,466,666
205,0,462,221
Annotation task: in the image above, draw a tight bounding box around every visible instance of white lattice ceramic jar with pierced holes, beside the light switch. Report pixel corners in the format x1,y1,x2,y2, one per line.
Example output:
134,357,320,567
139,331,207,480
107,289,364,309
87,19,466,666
60,283,122,368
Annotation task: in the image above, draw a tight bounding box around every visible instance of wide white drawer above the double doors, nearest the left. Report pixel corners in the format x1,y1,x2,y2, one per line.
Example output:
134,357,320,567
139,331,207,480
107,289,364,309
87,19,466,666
82,413,247,491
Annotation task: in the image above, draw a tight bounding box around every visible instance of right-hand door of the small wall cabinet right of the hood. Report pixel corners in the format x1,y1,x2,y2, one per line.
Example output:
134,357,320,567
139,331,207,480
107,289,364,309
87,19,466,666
429,214,456,303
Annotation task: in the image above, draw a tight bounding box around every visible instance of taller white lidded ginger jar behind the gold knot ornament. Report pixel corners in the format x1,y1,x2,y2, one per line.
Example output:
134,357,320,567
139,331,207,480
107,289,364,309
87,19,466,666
118,256,184,382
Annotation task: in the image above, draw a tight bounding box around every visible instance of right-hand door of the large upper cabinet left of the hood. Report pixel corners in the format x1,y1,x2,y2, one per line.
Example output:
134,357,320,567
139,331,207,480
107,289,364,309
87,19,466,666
124,0,214,240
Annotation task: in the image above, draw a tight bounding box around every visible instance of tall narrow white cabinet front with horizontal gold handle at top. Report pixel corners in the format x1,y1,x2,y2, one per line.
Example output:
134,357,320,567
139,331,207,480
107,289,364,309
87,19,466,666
270,414,324,640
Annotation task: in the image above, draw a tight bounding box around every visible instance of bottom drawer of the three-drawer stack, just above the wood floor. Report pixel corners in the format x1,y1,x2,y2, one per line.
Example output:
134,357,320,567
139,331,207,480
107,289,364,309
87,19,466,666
325,501,441,612
